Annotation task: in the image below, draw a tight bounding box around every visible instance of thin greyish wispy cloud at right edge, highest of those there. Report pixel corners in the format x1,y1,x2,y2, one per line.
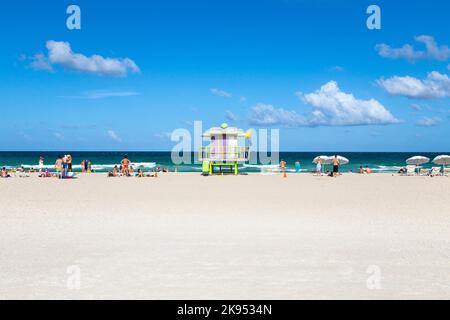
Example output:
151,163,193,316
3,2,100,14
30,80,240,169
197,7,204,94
375,35,450,62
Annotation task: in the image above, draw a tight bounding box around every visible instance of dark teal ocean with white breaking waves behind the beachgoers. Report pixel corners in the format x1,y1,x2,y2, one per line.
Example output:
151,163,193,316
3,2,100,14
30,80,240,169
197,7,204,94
0,151,450,172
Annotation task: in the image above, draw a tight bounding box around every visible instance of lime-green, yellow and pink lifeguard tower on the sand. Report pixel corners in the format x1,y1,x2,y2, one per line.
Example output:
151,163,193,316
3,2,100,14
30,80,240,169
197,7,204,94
199,123,251,174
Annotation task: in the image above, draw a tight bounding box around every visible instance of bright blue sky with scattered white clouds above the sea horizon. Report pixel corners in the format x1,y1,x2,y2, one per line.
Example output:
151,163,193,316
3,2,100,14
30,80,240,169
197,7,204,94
0,0,450,151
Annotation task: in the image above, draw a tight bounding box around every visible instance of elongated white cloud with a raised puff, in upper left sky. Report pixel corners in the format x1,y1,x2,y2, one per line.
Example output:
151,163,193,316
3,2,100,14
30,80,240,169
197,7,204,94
31,40,140,77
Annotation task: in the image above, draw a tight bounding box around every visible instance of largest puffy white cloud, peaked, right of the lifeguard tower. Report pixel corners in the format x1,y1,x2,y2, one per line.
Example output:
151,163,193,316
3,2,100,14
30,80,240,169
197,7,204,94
249,81,399,127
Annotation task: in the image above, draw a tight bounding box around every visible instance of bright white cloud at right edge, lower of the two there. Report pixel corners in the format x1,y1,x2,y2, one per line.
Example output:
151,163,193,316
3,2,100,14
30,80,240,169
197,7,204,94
377,71,450,99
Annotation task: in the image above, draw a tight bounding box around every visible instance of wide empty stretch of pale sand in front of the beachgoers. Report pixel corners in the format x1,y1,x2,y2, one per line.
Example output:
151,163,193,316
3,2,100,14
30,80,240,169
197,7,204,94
0,173,450,299
